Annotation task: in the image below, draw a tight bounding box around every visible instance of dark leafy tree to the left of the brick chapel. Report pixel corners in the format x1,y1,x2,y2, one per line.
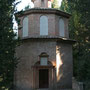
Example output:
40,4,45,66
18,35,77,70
0,0,17,90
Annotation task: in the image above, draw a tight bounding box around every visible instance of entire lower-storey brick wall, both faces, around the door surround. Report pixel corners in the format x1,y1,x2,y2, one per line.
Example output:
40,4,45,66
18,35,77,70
14,40,72,90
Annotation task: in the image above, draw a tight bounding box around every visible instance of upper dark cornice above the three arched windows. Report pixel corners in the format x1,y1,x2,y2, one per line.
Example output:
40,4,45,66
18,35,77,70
15,8,71,18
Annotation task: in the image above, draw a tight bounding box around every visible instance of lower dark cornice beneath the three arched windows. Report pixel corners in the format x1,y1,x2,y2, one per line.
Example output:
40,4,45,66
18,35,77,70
21,36,76,44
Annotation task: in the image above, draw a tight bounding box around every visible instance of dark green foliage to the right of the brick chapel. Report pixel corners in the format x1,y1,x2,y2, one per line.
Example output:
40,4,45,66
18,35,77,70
61,0,90,90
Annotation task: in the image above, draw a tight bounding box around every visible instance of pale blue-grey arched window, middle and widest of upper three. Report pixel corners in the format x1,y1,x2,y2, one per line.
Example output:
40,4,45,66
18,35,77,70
40,16,48,35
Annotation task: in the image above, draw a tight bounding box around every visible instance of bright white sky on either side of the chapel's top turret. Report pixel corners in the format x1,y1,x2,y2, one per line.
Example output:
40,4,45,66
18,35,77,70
16,0,62,11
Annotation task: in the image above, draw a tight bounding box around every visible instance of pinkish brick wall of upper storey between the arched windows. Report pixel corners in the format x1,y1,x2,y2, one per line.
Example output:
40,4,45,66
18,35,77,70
18,14,69,38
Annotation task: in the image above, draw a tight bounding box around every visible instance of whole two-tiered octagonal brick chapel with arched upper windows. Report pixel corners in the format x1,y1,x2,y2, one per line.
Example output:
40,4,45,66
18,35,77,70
14,0,74,90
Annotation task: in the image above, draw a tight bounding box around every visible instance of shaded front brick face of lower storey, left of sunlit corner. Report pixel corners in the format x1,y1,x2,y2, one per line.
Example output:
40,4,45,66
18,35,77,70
15,41,56,90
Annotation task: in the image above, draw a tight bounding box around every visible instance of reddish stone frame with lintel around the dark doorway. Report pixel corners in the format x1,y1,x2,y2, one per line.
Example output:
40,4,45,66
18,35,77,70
32,61,55,89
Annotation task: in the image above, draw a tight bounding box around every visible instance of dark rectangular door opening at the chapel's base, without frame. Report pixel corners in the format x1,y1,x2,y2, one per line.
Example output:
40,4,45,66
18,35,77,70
39,69,49,88
